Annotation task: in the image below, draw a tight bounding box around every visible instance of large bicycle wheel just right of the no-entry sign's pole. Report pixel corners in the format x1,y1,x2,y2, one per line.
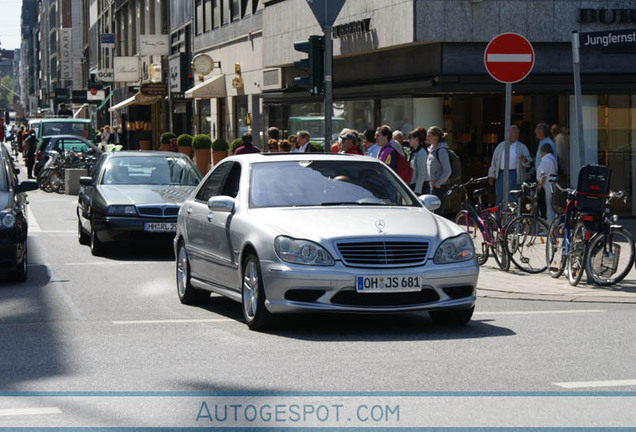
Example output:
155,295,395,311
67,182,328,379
504,216,549,273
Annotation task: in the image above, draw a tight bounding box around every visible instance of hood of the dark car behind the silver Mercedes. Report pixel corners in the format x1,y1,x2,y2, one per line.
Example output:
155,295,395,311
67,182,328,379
98,185,196,205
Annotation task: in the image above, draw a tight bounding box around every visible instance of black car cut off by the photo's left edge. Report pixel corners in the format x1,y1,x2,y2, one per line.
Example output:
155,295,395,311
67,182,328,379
0,146,38,282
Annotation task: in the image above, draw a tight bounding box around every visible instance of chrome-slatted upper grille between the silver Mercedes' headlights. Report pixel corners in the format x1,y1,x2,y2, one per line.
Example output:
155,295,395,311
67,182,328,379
336,241,428,267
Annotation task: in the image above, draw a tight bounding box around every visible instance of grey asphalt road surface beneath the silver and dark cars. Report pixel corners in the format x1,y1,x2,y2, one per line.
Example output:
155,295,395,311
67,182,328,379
0,182,636,427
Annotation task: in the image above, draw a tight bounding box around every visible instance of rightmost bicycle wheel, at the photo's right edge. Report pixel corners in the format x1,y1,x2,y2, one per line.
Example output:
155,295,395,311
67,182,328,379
585,227,634,286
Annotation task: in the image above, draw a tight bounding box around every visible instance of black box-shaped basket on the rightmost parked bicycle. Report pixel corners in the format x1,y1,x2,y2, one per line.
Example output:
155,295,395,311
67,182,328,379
575,165,612,215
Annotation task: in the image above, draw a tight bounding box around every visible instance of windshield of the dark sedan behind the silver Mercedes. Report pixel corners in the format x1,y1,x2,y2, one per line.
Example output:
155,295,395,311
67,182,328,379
102,156,201,186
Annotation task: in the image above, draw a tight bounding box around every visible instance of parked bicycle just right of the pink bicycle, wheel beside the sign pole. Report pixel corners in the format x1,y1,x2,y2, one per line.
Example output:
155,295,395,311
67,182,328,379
504,182,549,273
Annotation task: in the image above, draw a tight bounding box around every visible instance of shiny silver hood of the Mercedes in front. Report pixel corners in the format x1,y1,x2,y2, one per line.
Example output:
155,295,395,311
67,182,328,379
252,206,462,242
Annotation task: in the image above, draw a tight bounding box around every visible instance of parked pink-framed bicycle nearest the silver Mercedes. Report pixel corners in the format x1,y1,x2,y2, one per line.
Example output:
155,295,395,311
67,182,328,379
446,177,510,271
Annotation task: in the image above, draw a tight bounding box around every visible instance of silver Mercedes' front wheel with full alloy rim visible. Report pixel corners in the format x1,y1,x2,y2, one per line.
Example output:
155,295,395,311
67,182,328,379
241,253,272,331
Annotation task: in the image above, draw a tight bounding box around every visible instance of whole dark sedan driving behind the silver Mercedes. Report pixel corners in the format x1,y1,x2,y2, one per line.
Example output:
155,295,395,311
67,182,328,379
77,151,201,255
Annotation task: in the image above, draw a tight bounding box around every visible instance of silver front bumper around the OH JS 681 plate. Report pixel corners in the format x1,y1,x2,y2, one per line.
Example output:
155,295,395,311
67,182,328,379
261,260,479,313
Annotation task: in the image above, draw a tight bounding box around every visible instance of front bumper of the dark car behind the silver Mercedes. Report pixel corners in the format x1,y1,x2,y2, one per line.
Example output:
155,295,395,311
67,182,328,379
93,216,177,242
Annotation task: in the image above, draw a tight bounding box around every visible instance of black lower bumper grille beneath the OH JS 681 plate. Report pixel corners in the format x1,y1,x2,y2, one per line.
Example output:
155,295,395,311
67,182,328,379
331,288,439,306
